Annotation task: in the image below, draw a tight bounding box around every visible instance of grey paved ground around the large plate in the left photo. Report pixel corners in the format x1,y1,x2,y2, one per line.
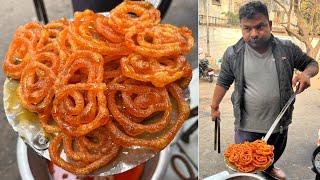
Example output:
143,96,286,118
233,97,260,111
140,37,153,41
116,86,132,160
0,0,198,180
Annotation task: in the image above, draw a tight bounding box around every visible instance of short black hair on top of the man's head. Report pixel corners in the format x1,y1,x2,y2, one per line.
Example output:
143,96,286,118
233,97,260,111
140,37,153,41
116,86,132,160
239,1,269,21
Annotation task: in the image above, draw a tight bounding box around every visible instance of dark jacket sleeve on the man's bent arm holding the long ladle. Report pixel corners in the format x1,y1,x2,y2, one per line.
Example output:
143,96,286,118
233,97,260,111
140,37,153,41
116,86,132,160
291,42,317,71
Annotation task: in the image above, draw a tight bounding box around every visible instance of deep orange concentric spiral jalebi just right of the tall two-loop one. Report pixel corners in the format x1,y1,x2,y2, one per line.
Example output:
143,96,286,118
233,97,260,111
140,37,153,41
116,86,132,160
108,78,171,136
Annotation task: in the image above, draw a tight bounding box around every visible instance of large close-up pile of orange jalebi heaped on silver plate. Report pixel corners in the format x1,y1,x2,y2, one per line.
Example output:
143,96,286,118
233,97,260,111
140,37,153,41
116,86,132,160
3,1,194,174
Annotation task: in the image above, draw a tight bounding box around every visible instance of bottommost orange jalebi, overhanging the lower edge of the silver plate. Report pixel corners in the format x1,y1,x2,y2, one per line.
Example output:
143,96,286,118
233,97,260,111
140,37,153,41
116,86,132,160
49,128,120,175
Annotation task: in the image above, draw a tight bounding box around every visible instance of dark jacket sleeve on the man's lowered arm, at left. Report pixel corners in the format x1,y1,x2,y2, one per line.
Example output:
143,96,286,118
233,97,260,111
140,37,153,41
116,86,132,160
217,47,235,90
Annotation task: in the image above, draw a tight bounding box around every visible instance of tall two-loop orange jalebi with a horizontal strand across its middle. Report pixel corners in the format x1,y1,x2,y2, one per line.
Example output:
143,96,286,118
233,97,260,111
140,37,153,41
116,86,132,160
52,51,108,136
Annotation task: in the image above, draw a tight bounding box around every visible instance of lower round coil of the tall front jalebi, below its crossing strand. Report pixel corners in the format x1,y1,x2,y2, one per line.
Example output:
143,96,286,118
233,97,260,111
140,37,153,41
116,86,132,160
52,83,109,137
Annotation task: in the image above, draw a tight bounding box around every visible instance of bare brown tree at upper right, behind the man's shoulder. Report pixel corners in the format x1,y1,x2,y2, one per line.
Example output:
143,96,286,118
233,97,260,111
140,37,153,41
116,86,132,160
274,0,320,61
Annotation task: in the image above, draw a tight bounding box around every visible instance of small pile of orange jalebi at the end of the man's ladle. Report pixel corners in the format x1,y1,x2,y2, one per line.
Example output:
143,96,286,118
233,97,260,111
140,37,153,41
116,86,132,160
224,140,274,172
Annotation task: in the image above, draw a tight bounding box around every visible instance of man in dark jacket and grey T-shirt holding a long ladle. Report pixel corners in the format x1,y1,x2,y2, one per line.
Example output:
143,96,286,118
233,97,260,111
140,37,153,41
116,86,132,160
211,1,318,179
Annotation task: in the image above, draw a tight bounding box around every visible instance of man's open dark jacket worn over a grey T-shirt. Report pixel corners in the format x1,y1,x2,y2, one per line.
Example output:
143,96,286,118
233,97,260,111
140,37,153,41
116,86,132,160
217,36,317,132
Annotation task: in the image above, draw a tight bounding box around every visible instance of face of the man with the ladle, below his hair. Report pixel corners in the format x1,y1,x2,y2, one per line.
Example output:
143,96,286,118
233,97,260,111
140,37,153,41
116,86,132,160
240,13,272,49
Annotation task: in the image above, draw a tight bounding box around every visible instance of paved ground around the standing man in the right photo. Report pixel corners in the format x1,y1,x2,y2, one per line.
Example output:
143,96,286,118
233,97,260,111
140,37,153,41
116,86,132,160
199,80,320,180
